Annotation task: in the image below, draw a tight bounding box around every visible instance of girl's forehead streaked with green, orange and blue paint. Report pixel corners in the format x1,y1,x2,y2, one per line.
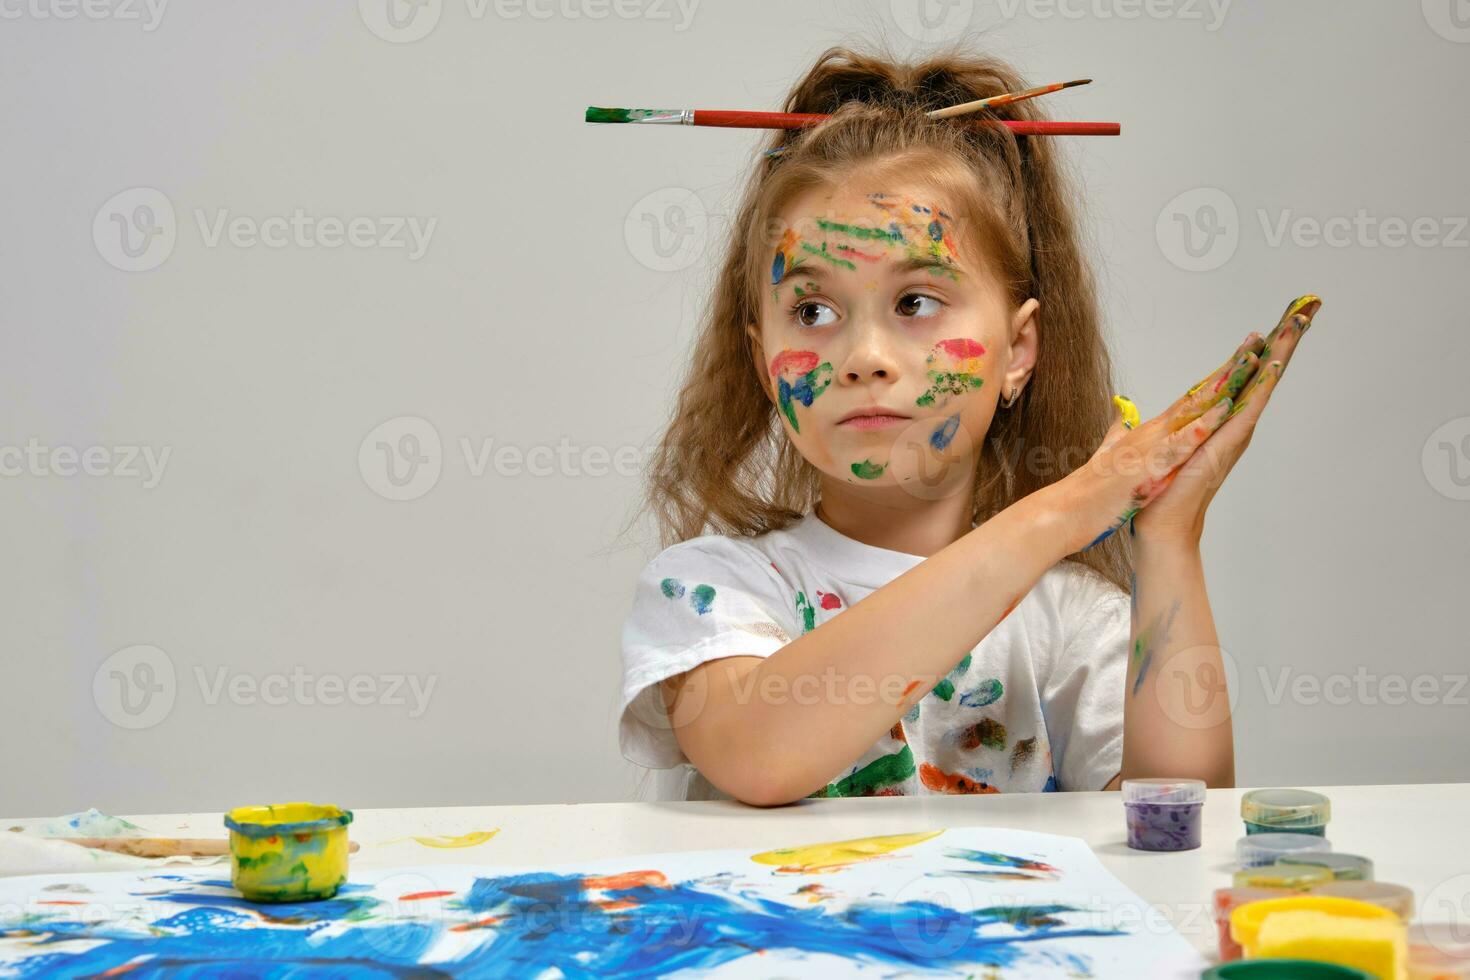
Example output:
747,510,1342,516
770,192,964,287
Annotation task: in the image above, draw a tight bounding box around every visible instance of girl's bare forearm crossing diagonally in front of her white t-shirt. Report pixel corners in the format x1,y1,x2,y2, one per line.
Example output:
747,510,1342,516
698,488,1079,802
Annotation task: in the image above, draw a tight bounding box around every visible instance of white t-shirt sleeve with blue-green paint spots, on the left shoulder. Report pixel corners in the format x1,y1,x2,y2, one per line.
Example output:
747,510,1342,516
617,535,797,768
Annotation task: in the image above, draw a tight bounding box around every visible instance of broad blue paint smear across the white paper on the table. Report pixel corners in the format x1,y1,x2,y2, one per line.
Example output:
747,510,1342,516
0,869,1122,980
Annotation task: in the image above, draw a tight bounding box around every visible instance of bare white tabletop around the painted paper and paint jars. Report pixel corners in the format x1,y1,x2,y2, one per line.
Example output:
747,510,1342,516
0,783,1470,958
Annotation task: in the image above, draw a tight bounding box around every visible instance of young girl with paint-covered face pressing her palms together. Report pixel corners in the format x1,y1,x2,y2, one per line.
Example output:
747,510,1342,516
620,48,1320,805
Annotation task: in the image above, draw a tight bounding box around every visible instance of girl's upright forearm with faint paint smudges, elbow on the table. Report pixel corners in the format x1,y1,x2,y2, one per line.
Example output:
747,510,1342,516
1122,532,1235,786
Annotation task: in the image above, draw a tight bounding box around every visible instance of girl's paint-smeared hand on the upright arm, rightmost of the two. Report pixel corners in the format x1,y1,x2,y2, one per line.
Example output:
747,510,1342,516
1128,294,1322,544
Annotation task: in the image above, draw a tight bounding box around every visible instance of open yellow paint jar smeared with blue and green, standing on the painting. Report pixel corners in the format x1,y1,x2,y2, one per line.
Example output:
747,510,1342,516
225,804,353,902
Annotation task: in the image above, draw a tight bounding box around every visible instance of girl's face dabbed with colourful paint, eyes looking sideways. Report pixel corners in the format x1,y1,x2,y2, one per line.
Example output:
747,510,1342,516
750,185,1038,500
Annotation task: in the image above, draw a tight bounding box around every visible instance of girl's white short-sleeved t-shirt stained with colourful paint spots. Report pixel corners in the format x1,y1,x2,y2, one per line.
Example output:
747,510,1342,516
619,511,1130,799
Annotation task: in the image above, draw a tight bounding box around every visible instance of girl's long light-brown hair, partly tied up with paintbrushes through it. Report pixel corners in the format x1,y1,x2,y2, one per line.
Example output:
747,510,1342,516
629,47,1132,588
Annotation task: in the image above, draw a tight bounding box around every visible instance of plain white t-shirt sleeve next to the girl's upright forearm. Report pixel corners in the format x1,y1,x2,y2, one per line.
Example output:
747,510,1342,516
1041,570,1132,789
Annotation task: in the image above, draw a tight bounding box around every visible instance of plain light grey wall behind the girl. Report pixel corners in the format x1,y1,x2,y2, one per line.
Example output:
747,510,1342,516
0,0,1470,814
